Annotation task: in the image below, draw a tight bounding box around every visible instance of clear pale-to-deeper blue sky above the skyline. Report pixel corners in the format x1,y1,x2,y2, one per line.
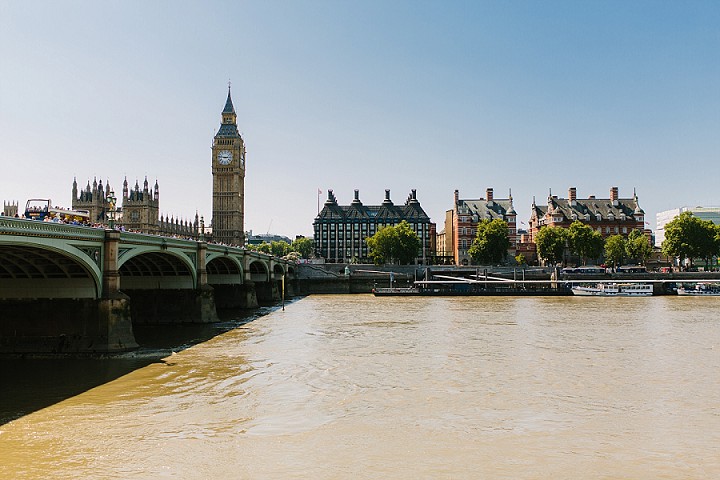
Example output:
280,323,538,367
0,0,720,238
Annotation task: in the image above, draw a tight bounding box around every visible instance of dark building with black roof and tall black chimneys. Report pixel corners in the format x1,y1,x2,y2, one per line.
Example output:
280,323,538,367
313,190,435,263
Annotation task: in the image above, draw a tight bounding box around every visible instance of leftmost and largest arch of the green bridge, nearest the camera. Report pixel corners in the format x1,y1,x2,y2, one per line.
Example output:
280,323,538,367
0,238,102,299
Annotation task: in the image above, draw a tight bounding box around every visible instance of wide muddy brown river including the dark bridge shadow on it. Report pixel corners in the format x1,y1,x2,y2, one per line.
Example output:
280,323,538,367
0,295,720,479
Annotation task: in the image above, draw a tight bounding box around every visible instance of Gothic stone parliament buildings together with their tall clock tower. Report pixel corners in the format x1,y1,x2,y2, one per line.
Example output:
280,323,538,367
72,85,245,246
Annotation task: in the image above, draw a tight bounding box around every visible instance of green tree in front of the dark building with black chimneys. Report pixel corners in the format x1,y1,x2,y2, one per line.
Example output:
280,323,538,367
365,220,420,265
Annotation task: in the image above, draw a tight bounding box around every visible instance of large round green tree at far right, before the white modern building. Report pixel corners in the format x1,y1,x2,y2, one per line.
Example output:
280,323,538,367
661,212,720,264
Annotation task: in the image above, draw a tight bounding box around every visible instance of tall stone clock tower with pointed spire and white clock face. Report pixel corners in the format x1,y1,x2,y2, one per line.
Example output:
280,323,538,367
212,85,245,246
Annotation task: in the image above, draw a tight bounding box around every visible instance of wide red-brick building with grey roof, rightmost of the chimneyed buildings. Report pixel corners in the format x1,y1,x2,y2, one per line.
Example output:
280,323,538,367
528,187,650,243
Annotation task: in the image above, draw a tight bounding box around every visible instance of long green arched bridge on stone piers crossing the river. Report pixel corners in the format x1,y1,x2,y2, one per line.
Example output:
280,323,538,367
0,217,296,353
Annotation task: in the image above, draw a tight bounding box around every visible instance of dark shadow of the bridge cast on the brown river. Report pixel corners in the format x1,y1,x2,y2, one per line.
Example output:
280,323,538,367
0,305,292,425
